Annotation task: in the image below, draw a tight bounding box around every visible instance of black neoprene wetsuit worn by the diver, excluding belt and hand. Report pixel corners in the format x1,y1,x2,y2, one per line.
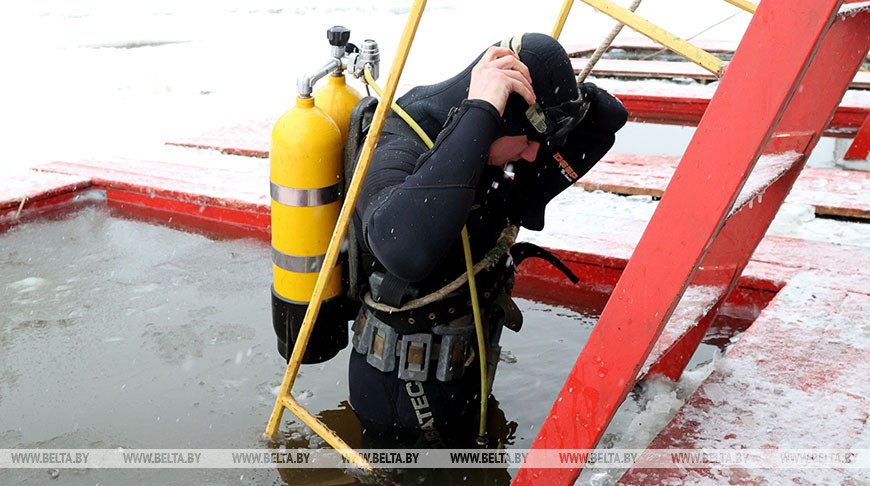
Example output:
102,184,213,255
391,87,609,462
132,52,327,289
350,34,625,444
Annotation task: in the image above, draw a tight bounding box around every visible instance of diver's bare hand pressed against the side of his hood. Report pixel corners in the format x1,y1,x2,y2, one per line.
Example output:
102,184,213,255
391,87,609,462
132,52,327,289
468,46,535,115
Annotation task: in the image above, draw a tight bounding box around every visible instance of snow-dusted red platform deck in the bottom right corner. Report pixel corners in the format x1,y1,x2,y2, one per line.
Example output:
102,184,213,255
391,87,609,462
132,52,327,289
632,272,870,484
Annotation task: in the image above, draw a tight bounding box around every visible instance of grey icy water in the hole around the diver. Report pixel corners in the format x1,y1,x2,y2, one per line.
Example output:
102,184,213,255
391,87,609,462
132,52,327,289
0,207,616,484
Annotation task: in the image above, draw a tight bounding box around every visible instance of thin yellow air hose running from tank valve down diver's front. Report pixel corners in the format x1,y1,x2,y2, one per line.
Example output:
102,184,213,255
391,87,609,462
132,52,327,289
365,69,489,445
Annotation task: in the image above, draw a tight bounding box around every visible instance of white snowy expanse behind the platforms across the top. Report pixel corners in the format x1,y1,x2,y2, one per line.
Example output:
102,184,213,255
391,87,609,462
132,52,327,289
0,0,750,176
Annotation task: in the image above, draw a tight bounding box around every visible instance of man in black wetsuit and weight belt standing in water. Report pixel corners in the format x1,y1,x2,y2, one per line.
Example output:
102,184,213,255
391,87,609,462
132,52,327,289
349,34,627,445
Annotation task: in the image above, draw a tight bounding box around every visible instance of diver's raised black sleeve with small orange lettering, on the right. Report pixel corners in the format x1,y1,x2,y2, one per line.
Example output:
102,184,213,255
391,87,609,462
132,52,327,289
508,83,628,231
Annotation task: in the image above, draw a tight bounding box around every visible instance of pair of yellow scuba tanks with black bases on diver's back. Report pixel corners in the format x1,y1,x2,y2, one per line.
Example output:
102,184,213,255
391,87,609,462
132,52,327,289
269,27,361,363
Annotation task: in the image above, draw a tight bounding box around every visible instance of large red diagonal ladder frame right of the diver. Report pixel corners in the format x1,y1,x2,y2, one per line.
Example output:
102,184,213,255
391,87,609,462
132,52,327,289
513,0,870,485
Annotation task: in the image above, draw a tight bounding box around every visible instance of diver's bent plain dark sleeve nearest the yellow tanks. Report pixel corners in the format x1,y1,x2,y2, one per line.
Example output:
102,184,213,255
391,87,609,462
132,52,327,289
357,100,501,282
